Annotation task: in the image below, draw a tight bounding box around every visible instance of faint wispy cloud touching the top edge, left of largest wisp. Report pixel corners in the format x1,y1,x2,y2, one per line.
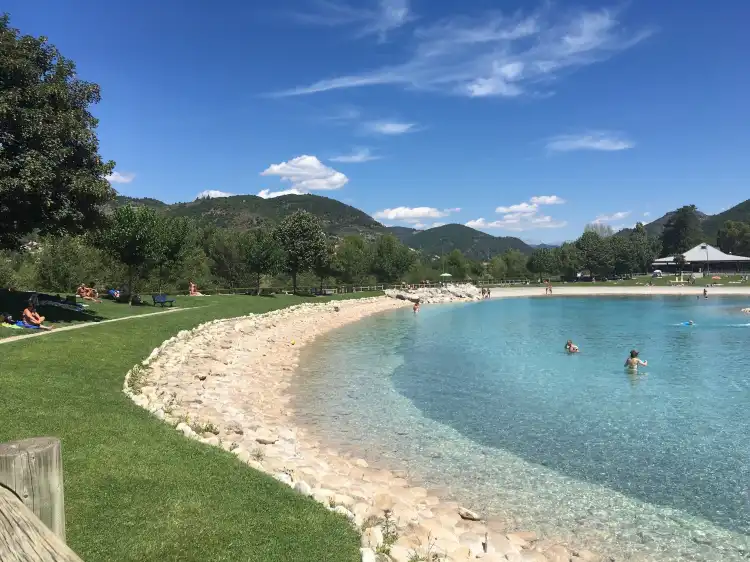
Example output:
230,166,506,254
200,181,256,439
292,0,415,43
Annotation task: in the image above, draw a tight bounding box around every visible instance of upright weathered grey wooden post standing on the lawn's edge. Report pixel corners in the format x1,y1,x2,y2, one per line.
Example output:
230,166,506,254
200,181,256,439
0,437,65,540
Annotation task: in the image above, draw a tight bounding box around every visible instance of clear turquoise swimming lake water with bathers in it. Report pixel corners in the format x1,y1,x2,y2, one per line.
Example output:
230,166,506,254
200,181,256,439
295,297,750,560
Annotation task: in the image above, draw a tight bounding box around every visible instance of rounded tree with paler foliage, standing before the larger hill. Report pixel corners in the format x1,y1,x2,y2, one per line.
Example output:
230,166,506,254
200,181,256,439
274,211,326,293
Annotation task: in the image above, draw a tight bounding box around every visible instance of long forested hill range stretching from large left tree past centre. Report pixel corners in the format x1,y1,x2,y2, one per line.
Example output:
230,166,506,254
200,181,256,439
114,191,533,255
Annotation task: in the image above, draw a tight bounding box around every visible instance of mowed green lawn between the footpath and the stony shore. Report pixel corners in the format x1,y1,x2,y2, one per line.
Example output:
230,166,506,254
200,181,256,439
0,294,382,562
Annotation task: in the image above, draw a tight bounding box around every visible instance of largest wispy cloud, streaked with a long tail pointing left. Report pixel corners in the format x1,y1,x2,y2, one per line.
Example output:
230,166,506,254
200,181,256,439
275,4,652,97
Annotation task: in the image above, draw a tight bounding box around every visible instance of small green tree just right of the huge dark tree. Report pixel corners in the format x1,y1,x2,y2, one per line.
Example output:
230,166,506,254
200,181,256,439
95,205,163,303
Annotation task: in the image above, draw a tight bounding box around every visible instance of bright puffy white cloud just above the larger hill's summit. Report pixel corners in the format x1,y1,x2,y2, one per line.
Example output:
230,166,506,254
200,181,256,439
258,154,349,192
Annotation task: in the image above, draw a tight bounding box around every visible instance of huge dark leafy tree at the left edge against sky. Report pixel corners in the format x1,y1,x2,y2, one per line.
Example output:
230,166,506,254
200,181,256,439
0,15,114,248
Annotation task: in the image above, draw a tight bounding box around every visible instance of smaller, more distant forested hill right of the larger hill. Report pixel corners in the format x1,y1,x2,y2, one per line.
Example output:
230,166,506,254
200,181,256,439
403,224,532,259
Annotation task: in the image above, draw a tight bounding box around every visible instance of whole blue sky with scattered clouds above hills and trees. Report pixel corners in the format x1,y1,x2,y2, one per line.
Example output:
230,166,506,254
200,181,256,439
3,0,750,242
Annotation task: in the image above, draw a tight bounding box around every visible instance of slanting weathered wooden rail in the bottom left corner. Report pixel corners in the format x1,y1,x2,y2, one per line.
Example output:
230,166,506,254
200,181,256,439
0,486,82,562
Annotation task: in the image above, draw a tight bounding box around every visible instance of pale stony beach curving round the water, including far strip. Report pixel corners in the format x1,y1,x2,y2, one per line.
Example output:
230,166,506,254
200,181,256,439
124,286,750,562
